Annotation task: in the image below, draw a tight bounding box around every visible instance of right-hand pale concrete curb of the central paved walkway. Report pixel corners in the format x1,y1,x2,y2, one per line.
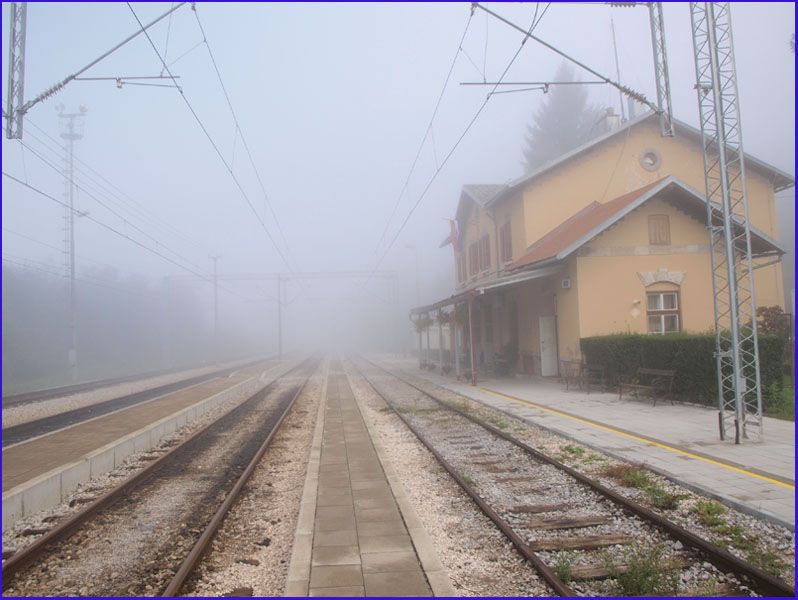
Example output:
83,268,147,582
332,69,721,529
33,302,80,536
344,371,457,596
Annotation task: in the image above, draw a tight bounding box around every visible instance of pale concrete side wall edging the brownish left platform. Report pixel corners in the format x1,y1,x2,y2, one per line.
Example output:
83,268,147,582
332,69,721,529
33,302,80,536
3,358,296,530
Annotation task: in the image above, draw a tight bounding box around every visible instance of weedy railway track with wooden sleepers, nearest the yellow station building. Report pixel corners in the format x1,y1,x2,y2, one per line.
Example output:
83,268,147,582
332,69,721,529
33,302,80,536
353,361,794,596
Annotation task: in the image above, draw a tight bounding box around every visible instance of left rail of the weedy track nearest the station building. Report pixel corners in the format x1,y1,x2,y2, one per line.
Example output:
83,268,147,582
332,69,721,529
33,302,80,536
352,359,576,597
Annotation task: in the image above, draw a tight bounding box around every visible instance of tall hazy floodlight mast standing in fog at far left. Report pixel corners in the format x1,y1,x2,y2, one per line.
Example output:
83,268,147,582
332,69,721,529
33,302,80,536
57,104,87,381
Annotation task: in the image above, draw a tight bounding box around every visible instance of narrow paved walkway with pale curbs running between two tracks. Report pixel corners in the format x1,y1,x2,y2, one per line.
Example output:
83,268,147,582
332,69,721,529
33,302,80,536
285,361,454,596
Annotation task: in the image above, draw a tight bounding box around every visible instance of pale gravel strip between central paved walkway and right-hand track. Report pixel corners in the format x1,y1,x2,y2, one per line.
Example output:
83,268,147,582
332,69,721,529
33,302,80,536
349,369,550,596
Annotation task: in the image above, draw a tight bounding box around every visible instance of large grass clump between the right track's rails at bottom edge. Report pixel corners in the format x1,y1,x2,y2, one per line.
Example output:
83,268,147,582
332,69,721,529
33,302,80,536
607,546,679,596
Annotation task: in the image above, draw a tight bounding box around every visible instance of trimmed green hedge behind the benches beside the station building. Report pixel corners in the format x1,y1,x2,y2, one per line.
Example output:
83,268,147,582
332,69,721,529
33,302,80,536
580,333,786,406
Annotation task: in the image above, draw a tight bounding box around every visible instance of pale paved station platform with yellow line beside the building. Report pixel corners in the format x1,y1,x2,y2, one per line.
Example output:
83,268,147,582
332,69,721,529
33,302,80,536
378,357,795,529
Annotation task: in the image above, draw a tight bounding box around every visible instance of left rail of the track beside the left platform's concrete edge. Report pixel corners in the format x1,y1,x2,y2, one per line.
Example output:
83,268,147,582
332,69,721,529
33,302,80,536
1,361,308,588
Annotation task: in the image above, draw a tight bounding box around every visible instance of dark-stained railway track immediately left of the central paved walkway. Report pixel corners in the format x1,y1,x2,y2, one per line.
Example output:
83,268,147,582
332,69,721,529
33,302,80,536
2,359,318,596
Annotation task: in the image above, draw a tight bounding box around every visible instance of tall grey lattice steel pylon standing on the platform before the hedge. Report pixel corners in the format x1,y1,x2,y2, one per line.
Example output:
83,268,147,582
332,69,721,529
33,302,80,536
690,2,762,444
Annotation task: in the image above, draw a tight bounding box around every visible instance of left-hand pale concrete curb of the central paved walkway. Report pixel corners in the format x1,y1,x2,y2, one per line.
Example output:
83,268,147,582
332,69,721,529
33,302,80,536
283,357,330,596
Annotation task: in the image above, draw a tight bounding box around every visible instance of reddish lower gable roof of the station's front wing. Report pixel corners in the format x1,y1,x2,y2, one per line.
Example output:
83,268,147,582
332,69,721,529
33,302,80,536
509,175,785,271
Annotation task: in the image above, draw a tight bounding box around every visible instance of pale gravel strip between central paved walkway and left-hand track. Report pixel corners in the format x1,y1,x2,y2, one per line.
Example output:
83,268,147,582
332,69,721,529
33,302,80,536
182,370,323,596
